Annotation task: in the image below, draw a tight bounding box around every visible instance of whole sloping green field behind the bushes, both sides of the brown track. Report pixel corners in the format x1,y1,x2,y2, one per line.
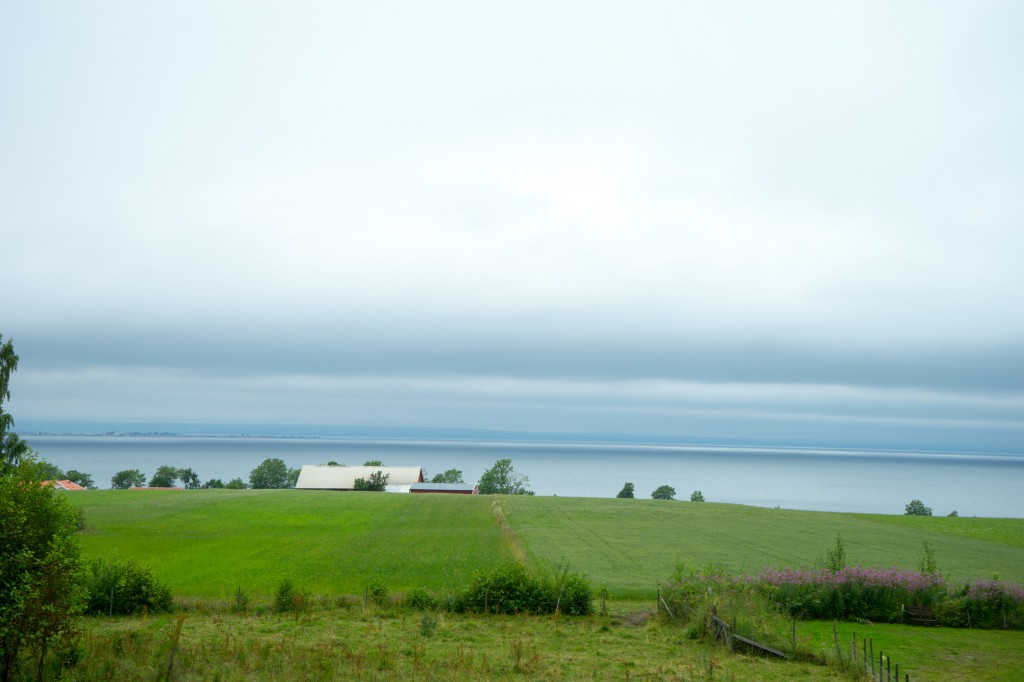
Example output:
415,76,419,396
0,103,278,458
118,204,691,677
69,491,1024,598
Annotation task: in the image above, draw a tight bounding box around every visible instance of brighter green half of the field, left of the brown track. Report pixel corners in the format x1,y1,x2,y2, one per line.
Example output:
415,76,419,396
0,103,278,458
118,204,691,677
72,491,506,598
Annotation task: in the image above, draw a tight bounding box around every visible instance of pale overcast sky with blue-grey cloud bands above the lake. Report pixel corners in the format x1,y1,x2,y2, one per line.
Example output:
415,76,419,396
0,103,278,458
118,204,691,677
0,0,1024,452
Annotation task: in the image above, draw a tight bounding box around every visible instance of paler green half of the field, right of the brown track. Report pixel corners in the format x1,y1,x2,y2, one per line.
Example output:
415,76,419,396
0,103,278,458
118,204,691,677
503,491,1024,595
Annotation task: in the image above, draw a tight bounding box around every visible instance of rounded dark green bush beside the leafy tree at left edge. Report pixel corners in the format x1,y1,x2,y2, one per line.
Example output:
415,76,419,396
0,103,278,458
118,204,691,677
84,559,174,614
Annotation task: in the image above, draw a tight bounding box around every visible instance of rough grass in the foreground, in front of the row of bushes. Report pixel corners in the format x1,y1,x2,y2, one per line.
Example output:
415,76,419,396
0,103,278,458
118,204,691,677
28,599,1024,682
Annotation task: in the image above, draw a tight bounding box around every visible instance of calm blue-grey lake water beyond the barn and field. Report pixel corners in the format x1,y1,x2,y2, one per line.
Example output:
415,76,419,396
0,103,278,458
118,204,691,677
26,436,1024,517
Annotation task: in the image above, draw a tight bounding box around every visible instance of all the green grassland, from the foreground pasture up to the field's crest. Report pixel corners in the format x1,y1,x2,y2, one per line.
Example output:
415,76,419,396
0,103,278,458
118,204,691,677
54,489,1024,682
